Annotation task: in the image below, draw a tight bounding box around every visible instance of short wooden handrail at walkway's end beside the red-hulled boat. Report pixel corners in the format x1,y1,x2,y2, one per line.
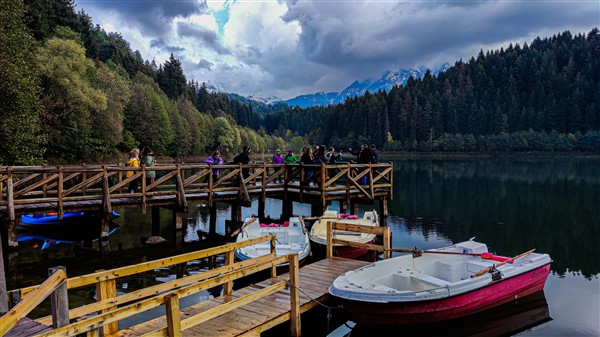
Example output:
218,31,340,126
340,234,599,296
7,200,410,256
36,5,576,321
327,221,391,259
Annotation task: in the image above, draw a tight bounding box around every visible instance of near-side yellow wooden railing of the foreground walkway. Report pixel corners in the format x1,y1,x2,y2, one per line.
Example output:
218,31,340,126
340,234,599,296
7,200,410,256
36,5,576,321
12,243,300,337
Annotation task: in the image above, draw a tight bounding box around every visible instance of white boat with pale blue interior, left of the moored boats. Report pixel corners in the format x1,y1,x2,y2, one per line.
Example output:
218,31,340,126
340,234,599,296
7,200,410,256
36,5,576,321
234,217,310,263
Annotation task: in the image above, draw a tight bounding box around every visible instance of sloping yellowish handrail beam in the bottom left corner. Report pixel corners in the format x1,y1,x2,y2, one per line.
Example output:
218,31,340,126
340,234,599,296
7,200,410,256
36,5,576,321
0,269,67,336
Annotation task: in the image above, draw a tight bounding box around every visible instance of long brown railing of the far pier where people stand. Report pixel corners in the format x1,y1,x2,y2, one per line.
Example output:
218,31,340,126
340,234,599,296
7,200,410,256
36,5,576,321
0,163,393,221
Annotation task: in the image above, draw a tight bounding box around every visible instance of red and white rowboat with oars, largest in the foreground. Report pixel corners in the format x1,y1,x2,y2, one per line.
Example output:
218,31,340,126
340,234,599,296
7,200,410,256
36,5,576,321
329,240,552,324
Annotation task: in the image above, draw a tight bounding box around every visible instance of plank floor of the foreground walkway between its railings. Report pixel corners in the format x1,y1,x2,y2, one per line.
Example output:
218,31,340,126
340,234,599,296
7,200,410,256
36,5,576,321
117,257,368,337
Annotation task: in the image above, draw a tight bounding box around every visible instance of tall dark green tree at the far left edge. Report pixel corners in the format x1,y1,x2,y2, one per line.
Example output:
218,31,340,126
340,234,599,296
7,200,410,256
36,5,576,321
0,0,45,165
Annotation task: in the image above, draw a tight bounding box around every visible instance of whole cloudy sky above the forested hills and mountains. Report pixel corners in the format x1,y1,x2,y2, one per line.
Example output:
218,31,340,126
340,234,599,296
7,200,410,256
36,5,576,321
76,0,600,99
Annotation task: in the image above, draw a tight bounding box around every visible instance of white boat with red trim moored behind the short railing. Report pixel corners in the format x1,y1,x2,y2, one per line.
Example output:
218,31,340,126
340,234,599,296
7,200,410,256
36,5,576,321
309,210,379,259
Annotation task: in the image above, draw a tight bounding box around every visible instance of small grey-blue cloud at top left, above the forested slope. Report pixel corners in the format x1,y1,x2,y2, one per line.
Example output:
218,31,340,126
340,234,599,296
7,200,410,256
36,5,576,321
82,0,207,36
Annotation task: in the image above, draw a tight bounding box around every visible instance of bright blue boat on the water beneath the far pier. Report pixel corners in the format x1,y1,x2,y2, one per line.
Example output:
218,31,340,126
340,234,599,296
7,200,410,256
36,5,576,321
19,211,121,227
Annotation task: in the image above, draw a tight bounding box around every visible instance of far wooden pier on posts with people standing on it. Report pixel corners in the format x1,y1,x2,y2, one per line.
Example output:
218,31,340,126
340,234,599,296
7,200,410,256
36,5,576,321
0,163,393,248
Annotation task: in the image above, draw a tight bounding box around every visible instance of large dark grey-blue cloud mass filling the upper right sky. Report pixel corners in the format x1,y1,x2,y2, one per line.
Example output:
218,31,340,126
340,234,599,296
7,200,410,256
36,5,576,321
282,1,599,73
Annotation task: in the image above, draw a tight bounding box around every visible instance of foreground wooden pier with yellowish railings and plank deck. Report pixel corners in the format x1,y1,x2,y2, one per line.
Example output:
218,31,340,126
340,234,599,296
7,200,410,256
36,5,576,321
0,224,391,337
